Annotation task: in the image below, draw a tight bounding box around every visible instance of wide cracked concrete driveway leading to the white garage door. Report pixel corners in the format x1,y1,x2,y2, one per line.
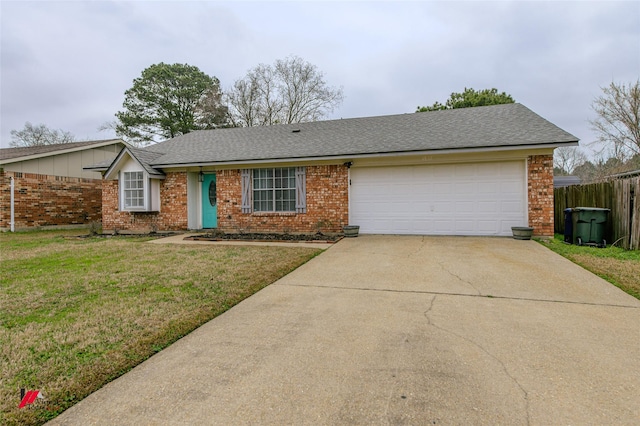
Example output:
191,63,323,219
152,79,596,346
51,236,640,425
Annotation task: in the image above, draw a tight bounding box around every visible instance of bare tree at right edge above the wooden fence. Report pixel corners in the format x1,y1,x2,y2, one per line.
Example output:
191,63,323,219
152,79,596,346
590,79,640,161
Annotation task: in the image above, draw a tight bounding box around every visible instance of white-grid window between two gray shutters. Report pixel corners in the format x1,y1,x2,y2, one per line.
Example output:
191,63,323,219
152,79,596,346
253,167,296,212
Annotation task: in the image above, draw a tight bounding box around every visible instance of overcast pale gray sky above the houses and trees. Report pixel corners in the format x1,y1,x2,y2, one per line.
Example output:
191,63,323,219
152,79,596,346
0,0,640,156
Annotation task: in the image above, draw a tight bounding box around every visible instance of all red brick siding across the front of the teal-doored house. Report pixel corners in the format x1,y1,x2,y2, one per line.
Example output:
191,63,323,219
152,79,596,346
102,154,553,237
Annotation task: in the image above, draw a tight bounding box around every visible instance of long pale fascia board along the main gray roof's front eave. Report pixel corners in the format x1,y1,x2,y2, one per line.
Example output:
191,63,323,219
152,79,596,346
152,141,578,169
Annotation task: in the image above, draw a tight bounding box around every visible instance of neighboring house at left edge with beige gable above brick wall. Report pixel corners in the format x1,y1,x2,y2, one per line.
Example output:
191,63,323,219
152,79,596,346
0,139,126,230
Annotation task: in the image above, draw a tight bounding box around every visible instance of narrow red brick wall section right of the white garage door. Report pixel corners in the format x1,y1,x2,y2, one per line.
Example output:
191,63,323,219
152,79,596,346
527,154,554,237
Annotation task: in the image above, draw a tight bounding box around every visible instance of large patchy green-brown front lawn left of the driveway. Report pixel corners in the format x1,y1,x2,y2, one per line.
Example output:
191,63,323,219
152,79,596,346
0,230,319,425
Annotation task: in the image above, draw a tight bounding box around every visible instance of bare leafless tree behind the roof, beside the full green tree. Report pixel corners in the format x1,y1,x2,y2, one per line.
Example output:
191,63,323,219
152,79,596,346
226,56,343,126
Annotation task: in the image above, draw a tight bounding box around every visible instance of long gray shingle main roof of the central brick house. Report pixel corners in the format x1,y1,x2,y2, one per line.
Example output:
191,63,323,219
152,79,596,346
146,104,578,167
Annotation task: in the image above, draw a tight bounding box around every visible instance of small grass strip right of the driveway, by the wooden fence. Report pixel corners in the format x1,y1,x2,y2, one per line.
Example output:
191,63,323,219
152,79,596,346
540,234,640,299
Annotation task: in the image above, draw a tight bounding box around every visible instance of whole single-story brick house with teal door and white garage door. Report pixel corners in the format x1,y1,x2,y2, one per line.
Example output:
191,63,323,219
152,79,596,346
97,104,578,237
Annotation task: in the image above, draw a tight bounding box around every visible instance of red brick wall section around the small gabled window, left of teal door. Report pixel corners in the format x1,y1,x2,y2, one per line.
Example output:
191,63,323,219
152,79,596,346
102,172,187,232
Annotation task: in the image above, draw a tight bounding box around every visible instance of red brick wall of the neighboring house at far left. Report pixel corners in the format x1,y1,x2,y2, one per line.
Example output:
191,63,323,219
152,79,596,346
0,172,102,229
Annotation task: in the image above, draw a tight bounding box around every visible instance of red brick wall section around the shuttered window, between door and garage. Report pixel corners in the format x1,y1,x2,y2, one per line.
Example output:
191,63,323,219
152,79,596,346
216,165,349,233
